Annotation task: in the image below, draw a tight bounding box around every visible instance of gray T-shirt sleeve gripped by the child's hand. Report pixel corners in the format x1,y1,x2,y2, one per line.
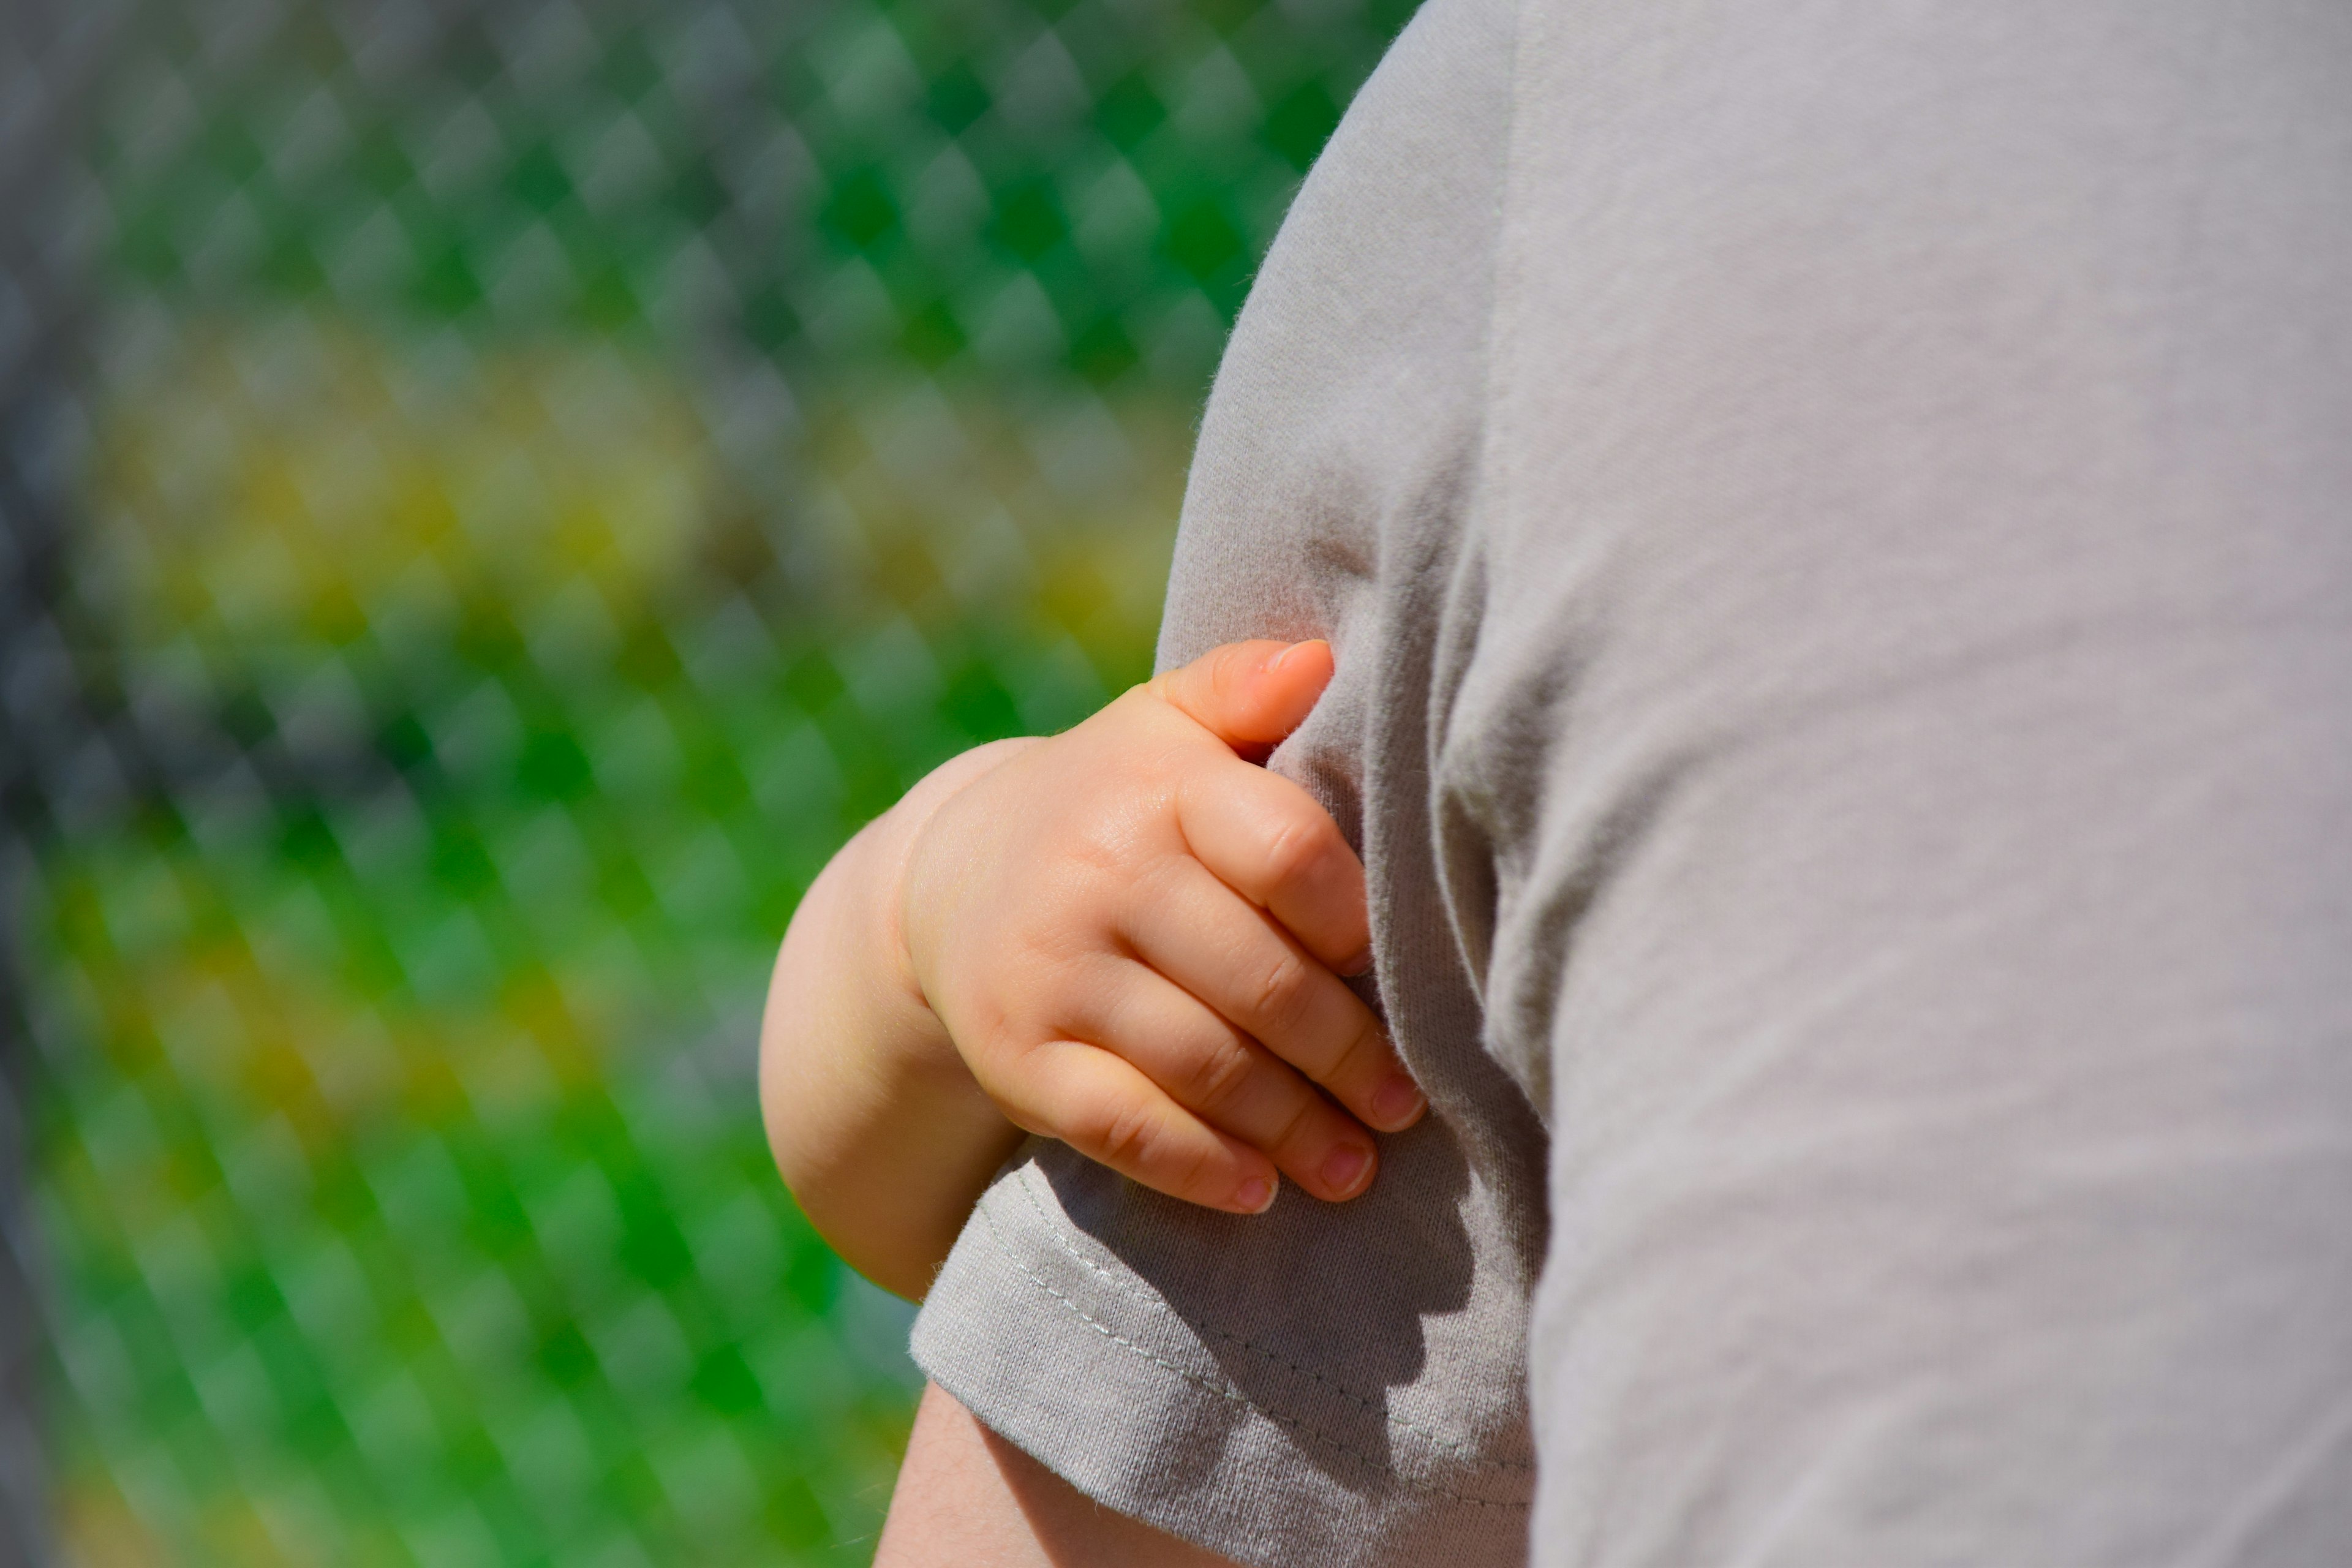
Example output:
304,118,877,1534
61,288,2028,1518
915,0,1545,1568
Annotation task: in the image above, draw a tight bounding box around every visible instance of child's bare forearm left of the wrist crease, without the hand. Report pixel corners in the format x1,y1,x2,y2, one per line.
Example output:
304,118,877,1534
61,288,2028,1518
760,743,1039,1300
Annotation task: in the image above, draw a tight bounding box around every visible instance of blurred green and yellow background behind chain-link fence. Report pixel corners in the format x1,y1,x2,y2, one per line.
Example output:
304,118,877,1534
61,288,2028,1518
0,0,1411,1568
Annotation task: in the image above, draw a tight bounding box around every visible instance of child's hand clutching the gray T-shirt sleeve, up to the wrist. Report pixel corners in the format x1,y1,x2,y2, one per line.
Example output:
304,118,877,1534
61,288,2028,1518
901,642,1423,1213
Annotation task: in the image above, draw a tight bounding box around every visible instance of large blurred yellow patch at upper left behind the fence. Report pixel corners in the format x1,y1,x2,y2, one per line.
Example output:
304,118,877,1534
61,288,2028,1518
92,315,722,642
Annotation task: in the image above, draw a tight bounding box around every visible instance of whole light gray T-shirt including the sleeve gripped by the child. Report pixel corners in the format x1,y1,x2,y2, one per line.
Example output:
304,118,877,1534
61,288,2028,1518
918,0,2352,1568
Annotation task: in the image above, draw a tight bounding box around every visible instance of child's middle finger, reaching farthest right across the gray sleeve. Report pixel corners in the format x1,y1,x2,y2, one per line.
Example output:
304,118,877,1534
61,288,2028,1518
1122,861,1428,1147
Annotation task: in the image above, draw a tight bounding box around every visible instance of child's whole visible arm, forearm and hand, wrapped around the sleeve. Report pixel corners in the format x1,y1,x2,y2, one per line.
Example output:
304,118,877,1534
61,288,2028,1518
762,642,1423,1298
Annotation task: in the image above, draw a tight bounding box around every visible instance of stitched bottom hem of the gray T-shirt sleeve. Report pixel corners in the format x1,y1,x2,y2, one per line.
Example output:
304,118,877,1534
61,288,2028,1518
915,1166,1534,1568
